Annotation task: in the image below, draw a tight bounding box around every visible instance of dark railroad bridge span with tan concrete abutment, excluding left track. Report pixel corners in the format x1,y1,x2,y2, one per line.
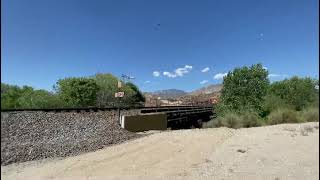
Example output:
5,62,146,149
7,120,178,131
120,106,215,131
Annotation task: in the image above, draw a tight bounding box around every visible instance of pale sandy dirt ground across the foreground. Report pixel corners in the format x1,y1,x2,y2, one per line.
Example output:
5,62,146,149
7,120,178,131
1,123,319,180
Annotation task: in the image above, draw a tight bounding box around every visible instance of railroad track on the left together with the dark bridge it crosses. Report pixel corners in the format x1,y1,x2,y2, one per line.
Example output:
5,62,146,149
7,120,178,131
1,105,215,131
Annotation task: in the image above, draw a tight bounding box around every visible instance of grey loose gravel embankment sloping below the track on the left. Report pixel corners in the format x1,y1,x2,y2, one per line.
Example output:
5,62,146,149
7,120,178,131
1,110,143,166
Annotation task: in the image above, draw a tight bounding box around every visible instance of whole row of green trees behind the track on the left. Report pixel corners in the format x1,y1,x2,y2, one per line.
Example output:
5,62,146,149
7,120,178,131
1,73,145,109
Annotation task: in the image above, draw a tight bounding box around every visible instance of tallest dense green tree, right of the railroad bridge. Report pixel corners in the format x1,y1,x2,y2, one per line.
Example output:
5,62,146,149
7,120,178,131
218,64,269,113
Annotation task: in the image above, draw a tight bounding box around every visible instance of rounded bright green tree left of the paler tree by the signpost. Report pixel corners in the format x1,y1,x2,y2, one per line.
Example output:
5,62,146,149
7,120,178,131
56,78,99,107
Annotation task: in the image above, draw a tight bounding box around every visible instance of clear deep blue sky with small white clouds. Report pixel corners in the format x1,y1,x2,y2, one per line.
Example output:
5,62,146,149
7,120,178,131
1,0,319,91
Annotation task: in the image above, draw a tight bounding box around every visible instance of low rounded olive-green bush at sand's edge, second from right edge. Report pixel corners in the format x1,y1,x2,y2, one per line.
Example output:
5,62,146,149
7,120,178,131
267,109,303,125
